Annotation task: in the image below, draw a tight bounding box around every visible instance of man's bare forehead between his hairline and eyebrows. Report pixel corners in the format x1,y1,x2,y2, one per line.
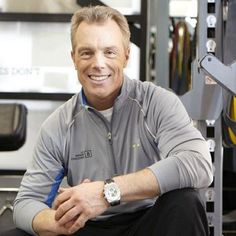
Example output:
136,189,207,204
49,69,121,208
75,19,123,46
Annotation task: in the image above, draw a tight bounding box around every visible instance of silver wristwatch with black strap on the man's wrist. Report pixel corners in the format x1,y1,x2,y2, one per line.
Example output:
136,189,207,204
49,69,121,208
103,179,120,206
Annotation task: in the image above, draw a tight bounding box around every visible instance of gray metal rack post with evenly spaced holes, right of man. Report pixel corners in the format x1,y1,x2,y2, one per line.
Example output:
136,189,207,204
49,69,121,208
198,0,223,236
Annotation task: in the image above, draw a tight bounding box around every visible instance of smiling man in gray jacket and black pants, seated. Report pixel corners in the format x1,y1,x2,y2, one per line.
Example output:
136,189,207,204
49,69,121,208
9,6,212,236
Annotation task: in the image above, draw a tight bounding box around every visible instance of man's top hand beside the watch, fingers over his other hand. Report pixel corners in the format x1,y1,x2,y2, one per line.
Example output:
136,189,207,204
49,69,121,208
54,181,109,234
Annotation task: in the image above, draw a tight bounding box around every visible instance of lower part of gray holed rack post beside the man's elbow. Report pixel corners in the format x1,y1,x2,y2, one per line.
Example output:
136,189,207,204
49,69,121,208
198,117,223,236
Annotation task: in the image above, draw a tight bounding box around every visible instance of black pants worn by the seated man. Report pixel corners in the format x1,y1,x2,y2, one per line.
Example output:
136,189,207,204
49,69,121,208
1,189,209,236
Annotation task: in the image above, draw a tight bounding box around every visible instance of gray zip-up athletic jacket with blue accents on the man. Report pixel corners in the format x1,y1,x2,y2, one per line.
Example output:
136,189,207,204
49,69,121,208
14,78,213,234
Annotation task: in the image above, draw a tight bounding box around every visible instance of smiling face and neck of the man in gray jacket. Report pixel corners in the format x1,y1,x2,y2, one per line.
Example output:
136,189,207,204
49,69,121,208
72,20,129,109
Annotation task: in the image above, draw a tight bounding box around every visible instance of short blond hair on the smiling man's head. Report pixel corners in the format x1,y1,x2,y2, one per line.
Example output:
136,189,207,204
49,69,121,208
71,6,130,50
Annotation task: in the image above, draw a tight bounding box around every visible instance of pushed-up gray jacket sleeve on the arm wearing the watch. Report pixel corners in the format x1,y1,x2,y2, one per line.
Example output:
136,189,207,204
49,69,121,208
149,87,213,194
